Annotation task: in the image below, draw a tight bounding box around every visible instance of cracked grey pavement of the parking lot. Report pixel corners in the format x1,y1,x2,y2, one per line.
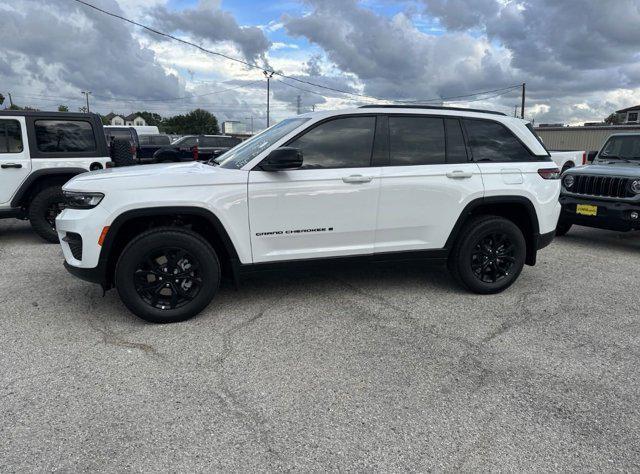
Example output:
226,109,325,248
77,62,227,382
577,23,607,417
0,220,640,472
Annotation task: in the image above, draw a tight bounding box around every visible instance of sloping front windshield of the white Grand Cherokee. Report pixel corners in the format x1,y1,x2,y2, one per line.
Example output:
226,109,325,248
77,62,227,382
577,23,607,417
215,118,309,169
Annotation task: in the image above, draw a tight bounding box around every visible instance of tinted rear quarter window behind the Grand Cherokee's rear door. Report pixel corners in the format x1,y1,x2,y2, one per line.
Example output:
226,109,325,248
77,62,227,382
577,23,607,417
464,119,532,162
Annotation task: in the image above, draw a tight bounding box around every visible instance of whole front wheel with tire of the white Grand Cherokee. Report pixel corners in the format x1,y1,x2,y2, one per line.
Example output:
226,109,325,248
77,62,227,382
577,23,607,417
115,227,221,323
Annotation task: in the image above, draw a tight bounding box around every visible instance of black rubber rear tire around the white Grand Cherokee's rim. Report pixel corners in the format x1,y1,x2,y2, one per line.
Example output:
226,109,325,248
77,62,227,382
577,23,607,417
448,215,527,294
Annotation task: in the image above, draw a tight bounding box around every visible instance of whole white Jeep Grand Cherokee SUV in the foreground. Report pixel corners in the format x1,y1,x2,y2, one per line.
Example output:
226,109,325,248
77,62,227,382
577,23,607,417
57,106,560,322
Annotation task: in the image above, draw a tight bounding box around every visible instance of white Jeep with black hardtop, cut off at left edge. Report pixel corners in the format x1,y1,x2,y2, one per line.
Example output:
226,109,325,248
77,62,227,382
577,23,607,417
0,110,111,242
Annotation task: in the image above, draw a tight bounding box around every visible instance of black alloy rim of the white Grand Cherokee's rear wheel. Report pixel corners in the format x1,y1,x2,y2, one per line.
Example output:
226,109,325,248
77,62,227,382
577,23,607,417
471,232,516,283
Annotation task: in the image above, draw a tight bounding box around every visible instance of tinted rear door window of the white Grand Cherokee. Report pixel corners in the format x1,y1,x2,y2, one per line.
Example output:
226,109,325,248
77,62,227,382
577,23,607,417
389,116,445,166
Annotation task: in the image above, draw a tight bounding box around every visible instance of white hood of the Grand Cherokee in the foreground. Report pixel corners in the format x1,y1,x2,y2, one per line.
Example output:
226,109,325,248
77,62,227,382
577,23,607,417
63,162,246,192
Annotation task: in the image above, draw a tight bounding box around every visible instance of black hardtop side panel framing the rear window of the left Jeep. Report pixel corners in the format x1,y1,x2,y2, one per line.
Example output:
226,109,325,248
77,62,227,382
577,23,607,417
25,113,109,159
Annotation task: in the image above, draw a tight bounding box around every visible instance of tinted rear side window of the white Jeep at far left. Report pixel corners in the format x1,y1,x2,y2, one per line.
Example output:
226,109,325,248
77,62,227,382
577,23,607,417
34,120,96,153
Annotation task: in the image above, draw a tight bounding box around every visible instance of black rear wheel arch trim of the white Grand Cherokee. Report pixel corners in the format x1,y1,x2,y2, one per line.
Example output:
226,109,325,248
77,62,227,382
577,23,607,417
445,196,540,265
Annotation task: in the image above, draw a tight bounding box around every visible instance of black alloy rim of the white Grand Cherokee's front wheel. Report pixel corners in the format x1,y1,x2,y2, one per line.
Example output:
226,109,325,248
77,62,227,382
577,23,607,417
134,247,202,310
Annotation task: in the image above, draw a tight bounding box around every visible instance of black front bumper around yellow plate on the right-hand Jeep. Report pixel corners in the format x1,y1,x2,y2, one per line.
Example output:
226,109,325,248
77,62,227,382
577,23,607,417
560,196,640,232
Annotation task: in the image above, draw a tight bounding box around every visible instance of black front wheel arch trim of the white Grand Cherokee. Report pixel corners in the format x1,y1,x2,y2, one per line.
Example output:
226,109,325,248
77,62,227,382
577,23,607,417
99,206,240,288
